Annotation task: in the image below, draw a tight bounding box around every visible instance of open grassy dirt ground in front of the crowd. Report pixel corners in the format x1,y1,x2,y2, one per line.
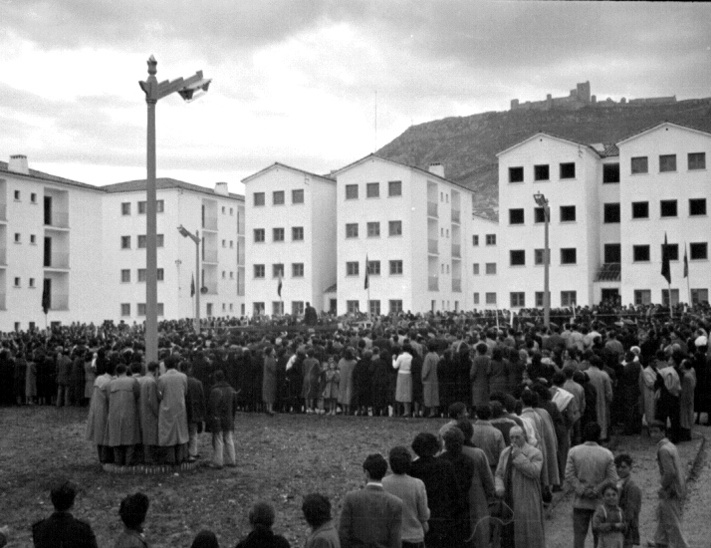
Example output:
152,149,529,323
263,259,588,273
0,407,711,548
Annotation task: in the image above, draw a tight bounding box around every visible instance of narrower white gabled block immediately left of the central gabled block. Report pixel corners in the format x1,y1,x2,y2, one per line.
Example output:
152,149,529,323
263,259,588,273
242,163,337,315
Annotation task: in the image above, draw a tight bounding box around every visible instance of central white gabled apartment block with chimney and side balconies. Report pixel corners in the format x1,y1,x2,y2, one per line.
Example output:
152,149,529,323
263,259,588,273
335,154,472,314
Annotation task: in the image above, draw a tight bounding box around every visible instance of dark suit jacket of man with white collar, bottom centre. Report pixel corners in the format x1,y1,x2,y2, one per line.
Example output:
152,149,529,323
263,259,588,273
338,484,402,548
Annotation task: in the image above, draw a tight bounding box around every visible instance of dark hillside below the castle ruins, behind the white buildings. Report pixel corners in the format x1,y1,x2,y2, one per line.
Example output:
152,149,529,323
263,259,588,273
377,99,711,217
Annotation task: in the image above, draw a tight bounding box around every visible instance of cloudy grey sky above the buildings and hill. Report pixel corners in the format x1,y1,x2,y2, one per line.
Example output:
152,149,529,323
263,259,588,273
0,0,711,192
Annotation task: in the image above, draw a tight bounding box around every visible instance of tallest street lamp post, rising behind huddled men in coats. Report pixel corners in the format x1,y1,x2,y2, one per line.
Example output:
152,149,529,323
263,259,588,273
138,55,210,363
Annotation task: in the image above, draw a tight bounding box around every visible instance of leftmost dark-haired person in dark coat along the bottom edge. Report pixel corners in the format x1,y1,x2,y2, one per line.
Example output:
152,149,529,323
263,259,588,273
32,481,96,548
